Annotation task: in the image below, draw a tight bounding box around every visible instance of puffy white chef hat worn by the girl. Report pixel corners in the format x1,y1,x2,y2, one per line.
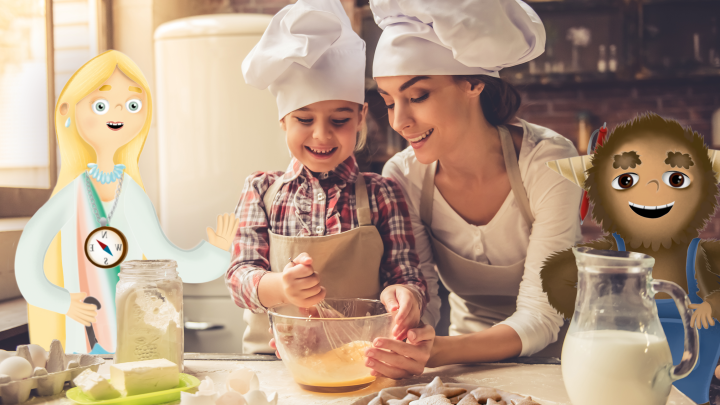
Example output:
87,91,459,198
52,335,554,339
242,0,365,119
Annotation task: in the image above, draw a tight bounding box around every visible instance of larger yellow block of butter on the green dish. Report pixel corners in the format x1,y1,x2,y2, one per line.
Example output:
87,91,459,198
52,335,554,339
110,359,180,396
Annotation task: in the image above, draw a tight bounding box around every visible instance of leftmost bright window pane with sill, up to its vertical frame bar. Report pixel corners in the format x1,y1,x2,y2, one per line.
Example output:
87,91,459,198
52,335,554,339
0,0,57,217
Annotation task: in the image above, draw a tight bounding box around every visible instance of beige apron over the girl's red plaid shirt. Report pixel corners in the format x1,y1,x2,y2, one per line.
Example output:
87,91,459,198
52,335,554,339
243,173,385,354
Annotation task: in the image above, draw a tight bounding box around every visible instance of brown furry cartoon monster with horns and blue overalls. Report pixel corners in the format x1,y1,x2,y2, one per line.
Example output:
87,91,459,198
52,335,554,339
540,113,720,403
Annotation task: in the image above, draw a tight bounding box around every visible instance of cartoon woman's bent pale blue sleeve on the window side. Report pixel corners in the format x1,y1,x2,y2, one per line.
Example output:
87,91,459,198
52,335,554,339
15,182,75,314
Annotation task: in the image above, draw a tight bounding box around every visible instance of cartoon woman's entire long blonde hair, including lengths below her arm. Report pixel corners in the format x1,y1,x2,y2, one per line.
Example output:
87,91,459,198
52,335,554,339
28,50,152,350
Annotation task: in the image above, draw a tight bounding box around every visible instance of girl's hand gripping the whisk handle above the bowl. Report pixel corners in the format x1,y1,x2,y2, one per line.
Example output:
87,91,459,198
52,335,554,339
282,253,325,308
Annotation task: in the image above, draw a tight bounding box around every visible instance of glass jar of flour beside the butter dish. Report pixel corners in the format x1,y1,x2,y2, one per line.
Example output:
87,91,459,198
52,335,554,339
115,260,184,371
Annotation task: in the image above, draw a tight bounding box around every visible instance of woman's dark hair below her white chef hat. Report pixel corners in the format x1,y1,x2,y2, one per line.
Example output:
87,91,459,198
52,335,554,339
453,75,522,126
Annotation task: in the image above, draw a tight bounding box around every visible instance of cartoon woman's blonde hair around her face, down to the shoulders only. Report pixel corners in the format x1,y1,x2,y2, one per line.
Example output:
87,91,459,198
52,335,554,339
52,50,152,195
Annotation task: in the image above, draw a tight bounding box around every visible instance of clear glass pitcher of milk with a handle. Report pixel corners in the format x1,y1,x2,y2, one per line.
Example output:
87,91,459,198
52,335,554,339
562,247,698,405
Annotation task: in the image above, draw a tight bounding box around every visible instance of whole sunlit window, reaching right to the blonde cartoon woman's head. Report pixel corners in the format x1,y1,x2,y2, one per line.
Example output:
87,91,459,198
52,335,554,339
0,0,112,218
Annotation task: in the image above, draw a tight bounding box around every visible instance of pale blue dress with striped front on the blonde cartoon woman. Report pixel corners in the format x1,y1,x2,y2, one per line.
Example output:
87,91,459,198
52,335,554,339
15,173,230,353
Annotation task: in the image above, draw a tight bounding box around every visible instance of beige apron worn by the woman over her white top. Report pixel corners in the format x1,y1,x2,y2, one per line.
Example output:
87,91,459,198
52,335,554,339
420,126,567,357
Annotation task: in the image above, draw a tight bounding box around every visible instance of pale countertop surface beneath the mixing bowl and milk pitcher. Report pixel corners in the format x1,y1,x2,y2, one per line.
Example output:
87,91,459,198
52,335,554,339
25,353,695,405
